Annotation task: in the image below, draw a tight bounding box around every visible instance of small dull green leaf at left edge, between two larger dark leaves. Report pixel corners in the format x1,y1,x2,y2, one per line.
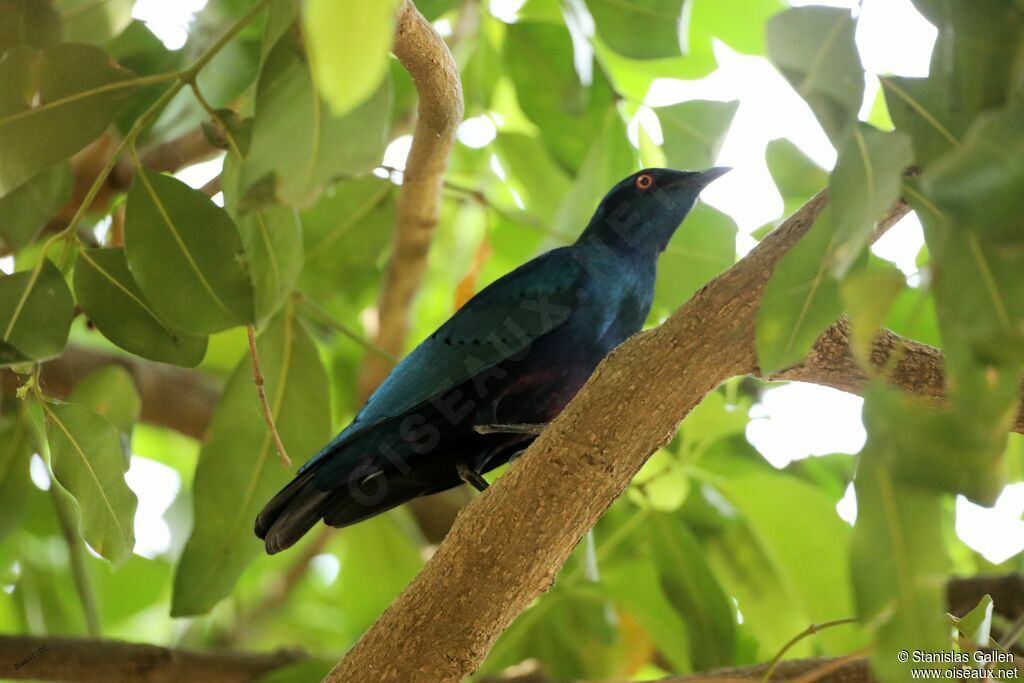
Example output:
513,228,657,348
0,164,72,251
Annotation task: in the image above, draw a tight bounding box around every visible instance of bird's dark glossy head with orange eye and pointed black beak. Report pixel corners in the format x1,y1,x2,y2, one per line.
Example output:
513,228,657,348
580,167,730,254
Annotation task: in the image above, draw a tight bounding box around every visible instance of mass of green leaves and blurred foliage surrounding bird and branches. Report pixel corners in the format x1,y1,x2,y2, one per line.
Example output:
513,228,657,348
0,0,1024,680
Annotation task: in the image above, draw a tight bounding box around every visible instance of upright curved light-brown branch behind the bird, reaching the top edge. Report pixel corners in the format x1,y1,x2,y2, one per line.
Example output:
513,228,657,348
359,0,463,398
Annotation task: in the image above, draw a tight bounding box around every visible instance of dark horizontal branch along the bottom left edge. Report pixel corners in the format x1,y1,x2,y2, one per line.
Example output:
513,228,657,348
0,636,305,683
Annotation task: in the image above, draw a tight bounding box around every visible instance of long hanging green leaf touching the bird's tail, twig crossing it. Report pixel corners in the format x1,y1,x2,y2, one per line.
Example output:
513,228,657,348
171,307,331,616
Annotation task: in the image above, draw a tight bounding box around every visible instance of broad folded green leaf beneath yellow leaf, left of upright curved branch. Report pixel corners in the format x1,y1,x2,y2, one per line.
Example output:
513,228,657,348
242,33,391,209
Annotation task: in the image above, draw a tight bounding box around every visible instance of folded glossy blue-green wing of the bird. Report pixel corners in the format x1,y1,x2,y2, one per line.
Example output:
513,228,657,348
303,247,584,469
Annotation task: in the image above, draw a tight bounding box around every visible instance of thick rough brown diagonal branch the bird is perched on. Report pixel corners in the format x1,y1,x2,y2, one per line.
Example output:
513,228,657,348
327,188,1024,683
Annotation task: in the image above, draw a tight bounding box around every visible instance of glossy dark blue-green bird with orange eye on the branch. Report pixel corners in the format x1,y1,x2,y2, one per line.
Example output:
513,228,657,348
255,167,730,554
